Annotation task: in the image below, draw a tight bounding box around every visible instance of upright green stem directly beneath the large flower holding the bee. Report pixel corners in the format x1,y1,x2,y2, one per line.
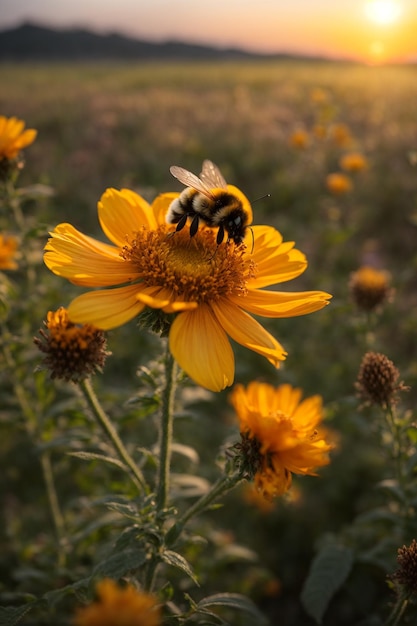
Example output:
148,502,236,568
156,346,177,511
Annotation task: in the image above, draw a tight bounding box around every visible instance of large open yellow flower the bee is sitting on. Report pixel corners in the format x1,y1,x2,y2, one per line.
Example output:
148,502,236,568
45,189,330,391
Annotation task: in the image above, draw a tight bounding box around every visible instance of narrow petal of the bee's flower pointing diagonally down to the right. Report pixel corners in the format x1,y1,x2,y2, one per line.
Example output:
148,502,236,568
211,299,287,367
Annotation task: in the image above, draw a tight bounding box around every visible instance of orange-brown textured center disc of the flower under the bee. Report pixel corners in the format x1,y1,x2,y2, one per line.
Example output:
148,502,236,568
122,226,255,303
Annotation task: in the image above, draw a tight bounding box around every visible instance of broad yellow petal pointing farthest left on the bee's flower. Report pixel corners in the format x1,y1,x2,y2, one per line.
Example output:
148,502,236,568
44,224,138,287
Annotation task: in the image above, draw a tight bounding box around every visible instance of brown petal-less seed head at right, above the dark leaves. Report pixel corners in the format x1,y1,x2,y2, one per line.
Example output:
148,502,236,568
355,352,408,408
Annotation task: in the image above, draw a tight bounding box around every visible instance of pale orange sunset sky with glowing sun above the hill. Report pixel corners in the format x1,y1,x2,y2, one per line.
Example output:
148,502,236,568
0,0,417,63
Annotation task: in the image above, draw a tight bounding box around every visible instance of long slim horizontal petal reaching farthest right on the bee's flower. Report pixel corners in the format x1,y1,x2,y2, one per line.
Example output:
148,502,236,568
234,290,332,317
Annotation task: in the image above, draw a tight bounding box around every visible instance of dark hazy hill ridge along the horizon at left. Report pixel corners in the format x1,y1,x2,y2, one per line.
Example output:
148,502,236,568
0,23,306,61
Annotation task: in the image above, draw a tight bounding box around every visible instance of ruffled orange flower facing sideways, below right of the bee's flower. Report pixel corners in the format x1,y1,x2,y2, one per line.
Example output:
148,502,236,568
231,382,332,498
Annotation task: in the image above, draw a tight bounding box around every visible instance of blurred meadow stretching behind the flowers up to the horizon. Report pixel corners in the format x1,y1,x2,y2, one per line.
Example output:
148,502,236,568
0,61,417,626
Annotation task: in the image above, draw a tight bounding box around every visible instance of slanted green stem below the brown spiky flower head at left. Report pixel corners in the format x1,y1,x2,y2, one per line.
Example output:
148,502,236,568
79,378,146,491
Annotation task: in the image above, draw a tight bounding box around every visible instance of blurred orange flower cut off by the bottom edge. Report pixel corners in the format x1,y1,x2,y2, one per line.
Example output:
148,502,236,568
72,578,162,626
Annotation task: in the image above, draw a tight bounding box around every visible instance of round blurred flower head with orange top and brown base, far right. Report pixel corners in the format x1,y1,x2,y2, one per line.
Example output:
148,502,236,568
349,265,393,312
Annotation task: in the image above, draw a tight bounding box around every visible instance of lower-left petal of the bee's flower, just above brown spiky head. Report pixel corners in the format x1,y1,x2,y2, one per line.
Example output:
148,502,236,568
68,285,145,330
